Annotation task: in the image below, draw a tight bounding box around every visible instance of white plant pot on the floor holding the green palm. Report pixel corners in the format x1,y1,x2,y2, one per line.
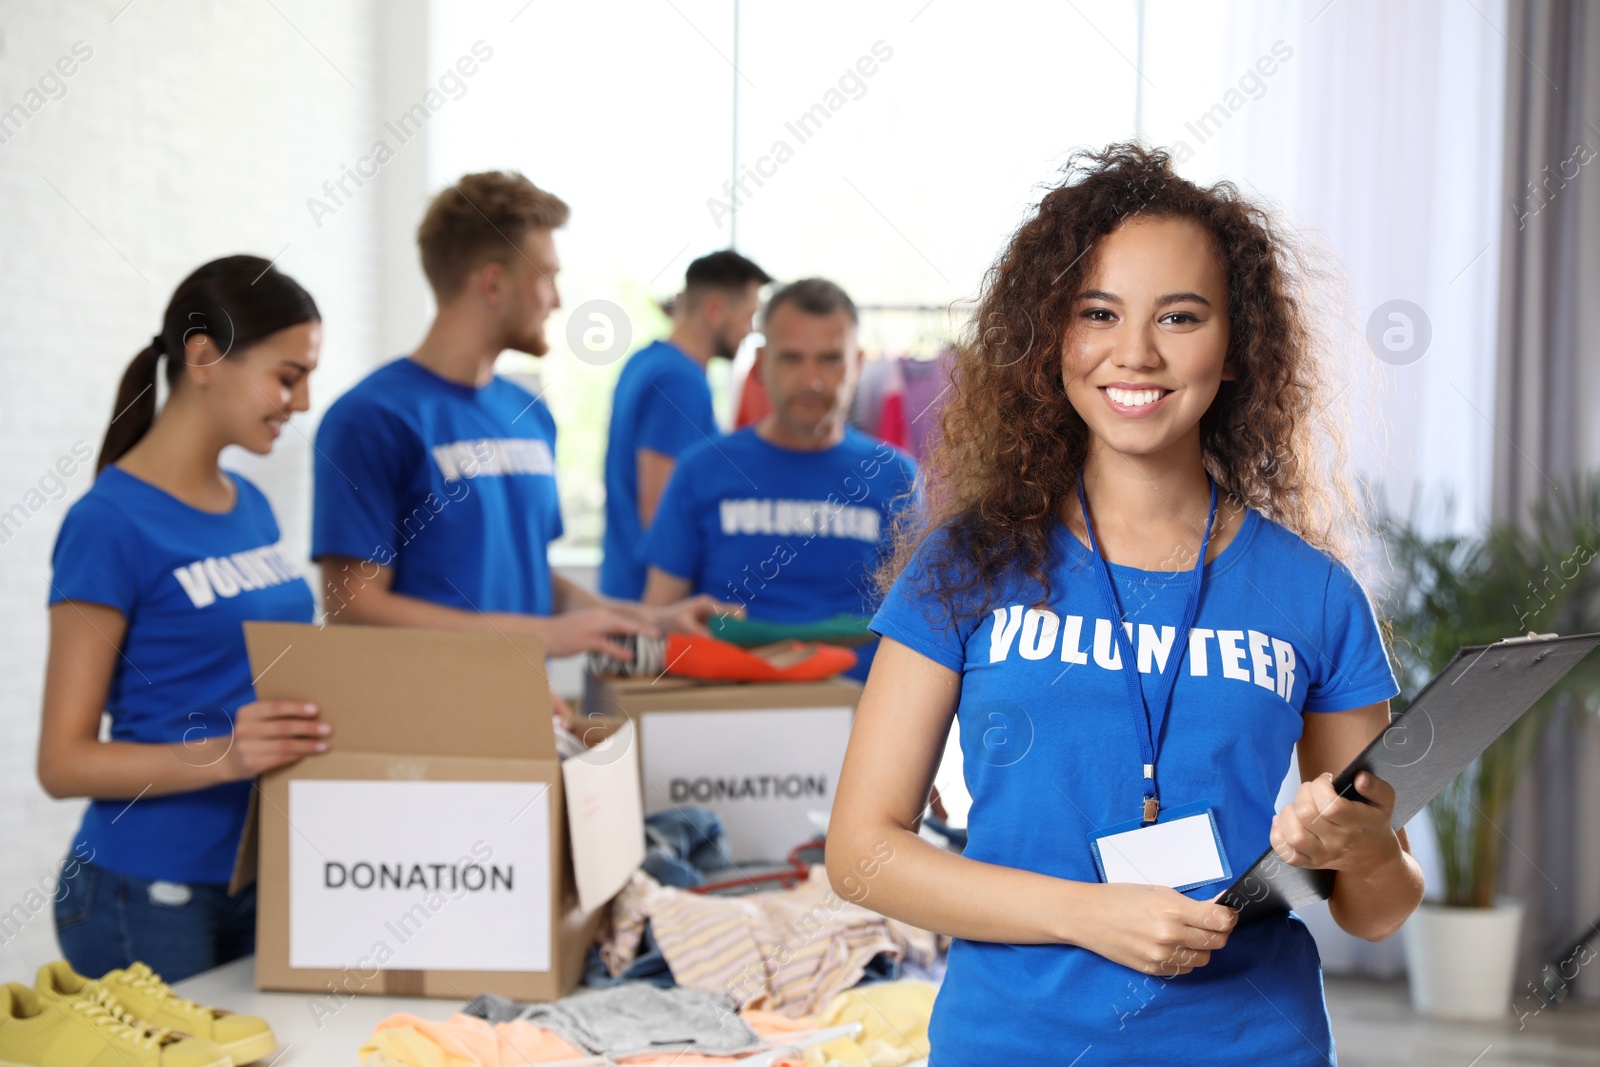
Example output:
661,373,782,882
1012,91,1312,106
1403,901,1522,1019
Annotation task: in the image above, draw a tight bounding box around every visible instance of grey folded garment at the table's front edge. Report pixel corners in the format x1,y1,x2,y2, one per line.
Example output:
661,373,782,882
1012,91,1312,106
462,984,766,1056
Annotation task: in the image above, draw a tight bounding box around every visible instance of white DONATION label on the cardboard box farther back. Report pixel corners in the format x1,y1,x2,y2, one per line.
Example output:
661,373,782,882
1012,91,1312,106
640,707,853,864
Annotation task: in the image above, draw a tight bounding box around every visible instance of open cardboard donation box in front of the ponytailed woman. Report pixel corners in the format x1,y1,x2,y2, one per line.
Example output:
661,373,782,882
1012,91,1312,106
235,622,643,1000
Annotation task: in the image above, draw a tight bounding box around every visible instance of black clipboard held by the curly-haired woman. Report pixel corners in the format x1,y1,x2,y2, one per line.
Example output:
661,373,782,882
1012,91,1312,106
1218,633,1600,923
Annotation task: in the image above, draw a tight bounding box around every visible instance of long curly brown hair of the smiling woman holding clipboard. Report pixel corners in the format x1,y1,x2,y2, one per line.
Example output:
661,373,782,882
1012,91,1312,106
878,142,1360,621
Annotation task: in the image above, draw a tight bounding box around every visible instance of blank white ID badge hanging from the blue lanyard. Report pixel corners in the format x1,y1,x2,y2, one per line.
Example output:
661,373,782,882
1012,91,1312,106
1090,803,1234,893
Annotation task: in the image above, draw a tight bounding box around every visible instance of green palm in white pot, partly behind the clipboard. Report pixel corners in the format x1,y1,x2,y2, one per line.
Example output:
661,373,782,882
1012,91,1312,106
1381,477,1600,1019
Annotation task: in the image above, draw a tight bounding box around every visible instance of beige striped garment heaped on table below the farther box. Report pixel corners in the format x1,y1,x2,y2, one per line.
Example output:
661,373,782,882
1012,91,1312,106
600,869,939,1016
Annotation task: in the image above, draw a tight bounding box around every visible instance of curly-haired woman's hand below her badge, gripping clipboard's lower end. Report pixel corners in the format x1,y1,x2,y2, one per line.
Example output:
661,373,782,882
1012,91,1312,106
1074,883,1238,977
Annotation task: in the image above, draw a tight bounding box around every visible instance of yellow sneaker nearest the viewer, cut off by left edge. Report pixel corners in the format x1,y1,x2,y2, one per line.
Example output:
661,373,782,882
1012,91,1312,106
0,982,229,1067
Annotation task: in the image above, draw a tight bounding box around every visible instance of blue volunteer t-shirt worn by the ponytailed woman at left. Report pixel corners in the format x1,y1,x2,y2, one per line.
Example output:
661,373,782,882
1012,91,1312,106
50,467,315,885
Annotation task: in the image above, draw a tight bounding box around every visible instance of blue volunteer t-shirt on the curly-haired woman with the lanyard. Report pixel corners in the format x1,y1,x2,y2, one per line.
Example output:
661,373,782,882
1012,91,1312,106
874,512,1398,1067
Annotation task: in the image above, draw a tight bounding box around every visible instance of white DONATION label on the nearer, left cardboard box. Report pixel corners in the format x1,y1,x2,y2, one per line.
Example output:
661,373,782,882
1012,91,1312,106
288,779,550,973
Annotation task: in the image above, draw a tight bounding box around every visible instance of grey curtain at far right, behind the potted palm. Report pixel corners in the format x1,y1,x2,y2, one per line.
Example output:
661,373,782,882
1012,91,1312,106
1494,0,1600,997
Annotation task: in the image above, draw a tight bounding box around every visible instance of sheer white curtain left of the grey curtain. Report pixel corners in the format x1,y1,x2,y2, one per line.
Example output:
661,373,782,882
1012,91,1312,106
1144,0,1507,977
